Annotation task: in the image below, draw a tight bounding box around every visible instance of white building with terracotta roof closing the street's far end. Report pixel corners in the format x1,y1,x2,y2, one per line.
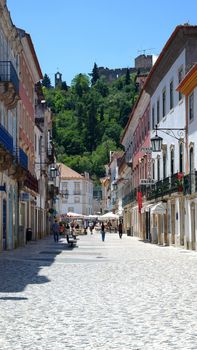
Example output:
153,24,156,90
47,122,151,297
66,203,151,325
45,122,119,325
57,163,93,215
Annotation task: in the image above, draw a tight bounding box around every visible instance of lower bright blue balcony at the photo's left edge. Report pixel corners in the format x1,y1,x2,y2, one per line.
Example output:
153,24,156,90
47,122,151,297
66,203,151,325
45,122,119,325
0,124,13,171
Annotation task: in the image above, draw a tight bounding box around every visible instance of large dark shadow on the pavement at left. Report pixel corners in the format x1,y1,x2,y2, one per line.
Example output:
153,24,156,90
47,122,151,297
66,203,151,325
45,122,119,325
0,238,75,300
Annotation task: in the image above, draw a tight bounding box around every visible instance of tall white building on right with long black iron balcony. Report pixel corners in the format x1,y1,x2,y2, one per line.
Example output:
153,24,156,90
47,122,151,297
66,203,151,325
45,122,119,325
144,25,197,247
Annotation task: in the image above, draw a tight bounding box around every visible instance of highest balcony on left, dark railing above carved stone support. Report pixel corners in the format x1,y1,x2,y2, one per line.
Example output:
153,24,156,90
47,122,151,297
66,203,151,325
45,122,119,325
0,61,20,109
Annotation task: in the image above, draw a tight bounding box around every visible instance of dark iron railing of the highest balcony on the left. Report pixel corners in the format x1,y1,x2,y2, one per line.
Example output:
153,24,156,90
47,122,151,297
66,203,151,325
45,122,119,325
0,61,19,94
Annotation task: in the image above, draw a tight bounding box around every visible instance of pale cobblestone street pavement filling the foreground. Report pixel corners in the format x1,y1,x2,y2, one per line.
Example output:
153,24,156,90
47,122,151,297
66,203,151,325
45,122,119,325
0,234,197,350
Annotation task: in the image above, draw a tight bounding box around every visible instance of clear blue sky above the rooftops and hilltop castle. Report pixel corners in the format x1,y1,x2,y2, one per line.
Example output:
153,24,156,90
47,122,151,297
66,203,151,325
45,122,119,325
7,0,197,85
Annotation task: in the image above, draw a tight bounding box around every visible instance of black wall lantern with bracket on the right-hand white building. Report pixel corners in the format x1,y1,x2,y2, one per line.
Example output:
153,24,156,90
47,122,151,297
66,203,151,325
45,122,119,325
151,125,186,152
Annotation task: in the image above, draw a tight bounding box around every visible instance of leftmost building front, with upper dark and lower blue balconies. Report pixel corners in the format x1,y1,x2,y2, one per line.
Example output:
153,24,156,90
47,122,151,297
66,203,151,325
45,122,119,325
0,0,21,251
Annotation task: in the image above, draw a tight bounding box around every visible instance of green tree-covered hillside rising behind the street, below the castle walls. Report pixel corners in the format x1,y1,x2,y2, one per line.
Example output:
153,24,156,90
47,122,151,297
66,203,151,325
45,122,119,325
42,64,137,180
